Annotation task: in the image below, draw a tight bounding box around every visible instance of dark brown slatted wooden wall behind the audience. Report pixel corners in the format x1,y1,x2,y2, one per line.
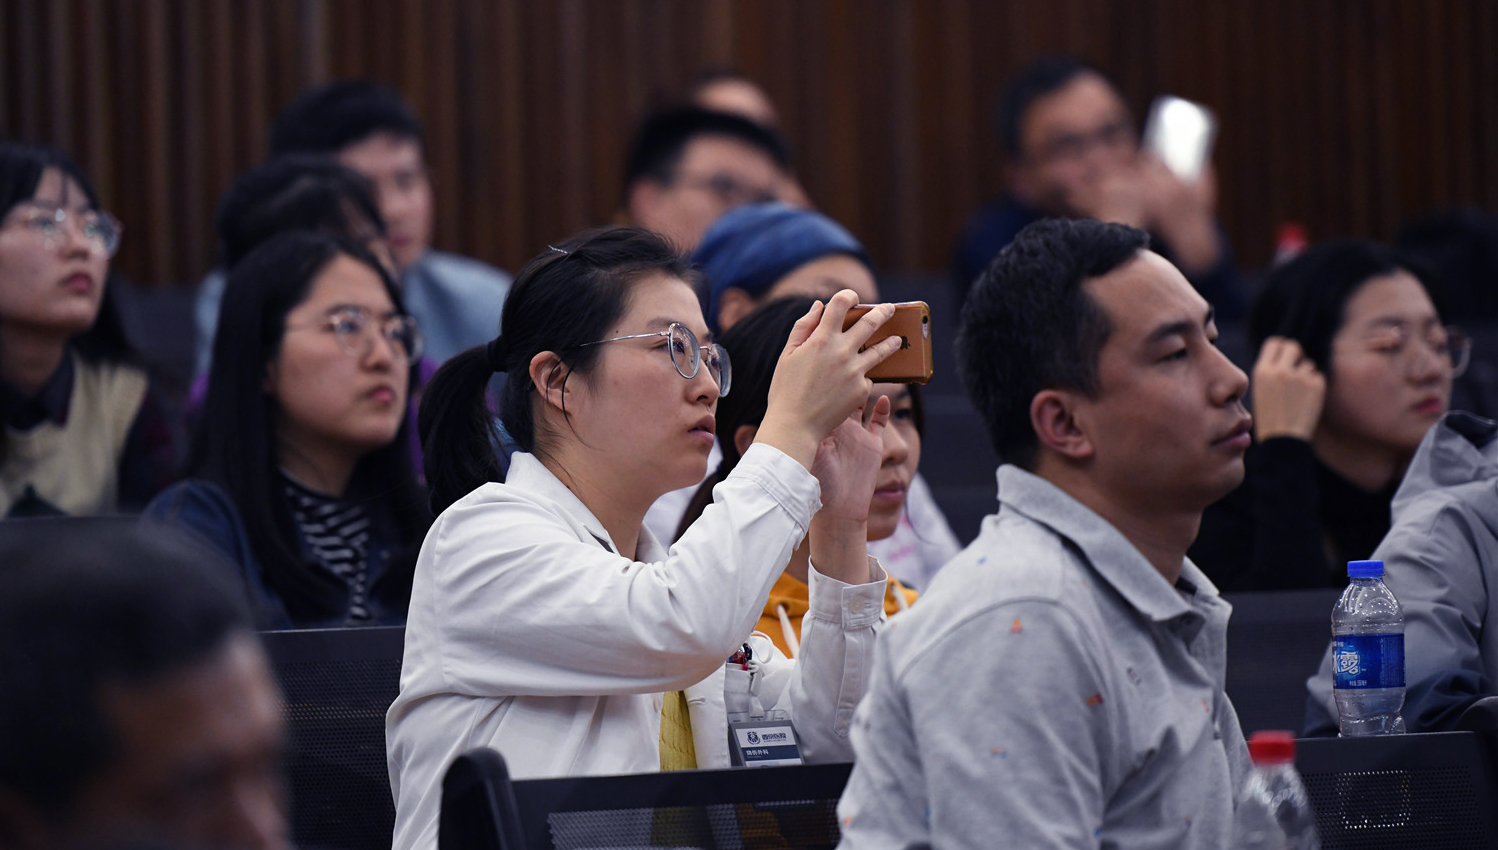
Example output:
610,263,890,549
0,0,1498,285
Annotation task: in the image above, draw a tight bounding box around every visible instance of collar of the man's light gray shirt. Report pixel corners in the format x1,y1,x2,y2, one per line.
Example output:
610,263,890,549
998,463,1218,622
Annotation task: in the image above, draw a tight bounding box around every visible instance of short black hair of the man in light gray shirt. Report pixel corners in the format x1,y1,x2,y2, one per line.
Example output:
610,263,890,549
956,219,1149,469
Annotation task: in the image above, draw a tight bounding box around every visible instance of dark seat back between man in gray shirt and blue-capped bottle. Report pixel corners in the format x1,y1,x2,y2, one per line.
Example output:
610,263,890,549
1224,588,1342,735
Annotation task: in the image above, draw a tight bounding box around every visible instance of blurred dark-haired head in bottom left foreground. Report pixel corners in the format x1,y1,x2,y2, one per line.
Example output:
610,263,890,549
0,519,288,850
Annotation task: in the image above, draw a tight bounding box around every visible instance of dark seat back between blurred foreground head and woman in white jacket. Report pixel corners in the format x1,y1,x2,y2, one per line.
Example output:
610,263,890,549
262,627,406,850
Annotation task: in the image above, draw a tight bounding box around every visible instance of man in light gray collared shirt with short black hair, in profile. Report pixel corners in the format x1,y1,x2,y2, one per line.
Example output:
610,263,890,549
839,219,1249,849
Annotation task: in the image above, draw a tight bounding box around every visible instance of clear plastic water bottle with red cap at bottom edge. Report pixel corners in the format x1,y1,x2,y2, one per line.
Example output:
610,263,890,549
1233,732,1321,850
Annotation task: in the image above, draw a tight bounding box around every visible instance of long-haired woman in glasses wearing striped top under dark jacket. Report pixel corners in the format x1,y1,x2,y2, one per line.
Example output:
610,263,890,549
147,232,430,628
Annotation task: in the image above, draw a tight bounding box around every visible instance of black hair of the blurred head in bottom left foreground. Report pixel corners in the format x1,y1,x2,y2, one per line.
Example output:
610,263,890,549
0,517,253,821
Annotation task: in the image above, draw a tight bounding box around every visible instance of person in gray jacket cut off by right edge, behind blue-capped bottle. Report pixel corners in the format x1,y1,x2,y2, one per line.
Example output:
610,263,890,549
1306,411,1498,735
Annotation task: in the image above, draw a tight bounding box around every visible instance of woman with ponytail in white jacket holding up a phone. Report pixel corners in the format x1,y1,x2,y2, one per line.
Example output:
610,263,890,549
386,228,897,849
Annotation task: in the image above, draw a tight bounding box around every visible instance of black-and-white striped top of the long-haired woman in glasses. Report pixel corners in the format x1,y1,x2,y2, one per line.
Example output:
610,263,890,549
282,472,370,625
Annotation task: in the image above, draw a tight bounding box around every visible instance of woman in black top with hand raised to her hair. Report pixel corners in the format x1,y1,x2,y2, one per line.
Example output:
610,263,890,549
1189,240,1470,591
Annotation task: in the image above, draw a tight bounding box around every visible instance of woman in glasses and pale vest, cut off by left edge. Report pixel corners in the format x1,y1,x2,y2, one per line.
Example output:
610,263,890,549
0,142,175,516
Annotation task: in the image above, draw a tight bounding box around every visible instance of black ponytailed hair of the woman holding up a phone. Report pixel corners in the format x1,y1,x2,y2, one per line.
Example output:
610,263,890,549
418,228,698,514
